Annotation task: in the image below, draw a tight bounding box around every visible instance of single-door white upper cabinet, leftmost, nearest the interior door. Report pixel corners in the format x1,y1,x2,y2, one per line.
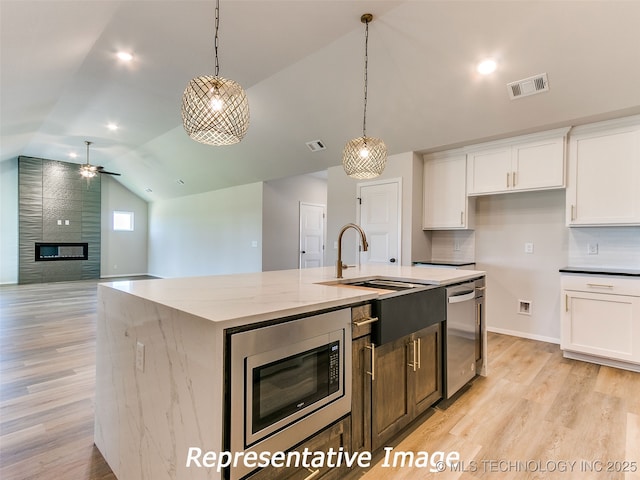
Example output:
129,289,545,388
422,150,475,230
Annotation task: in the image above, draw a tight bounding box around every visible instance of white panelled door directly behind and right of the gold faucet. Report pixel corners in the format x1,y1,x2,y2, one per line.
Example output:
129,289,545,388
358,179,402,264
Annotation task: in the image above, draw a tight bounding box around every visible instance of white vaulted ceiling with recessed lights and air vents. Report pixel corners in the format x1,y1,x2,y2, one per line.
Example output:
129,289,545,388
0,0,640,200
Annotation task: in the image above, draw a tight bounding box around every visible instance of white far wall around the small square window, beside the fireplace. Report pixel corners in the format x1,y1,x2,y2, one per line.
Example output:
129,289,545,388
100,175,148,278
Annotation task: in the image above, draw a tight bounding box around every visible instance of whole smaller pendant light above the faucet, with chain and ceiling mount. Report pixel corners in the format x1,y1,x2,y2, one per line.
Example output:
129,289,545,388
342,13,387,179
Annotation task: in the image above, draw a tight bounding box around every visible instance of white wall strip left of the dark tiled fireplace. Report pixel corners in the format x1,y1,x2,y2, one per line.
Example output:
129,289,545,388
0,158,18,285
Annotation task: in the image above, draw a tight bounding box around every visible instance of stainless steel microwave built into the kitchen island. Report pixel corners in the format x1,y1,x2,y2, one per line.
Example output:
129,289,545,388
229,308,351,480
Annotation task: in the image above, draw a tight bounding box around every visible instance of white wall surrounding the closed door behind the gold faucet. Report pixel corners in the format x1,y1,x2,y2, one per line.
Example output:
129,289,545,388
326,152,430,265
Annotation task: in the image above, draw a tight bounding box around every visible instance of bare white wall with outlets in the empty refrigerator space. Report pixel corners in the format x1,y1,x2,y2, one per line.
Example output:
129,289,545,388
475,190,569,343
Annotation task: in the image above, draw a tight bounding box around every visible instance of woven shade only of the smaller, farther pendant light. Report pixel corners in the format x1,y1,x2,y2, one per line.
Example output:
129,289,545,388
342,137,387,179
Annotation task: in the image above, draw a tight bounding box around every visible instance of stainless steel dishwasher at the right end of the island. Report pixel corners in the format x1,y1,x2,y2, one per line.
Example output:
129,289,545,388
445,281,477,399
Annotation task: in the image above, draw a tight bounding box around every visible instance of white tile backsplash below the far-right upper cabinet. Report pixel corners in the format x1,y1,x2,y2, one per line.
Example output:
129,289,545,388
568,227,640,269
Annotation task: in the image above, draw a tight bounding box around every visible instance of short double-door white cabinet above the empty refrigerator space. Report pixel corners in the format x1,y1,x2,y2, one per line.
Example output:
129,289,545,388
466,128,569,195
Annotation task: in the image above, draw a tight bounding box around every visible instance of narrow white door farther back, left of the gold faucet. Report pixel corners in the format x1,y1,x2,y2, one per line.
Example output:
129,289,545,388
299,202,325,268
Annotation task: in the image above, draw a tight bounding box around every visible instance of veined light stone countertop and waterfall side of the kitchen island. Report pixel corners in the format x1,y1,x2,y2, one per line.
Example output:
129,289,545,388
95,265,484,480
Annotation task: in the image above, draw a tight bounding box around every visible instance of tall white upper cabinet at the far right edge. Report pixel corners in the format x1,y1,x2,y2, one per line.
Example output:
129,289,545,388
566,115,640,226
